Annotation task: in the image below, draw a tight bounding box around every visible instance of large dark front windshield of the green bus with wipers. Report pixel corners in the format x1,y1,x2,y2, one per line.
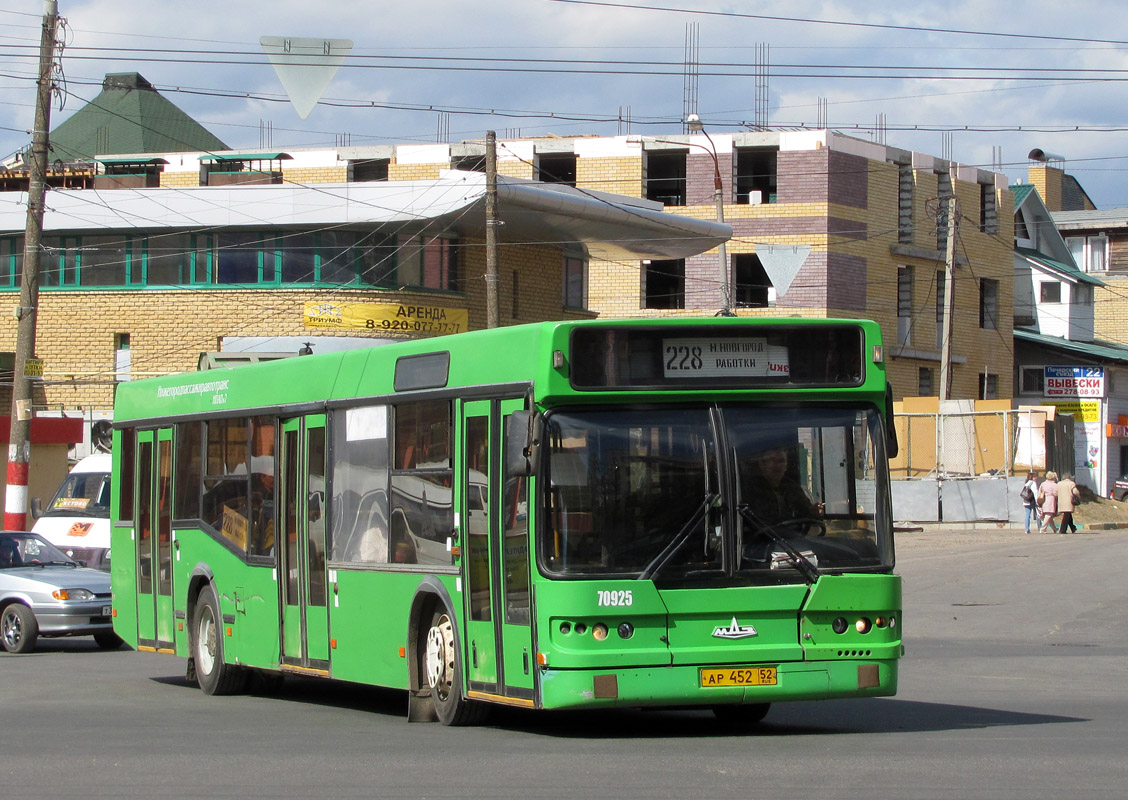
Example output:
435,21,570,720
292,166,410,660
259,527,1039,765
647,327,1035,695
538,405,892,582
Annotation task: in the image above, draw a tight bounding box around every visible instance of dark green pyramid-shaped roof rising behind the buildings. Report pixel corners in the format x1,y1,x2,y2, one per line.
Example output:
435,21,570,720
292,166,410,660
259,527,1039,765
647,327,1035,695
50,72,229,161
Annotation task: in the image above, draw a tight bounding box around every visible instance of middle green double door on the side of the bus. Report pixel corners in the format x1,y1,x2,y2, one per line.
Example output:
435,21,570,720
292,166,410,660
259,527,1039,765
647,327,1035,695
275,414,329,671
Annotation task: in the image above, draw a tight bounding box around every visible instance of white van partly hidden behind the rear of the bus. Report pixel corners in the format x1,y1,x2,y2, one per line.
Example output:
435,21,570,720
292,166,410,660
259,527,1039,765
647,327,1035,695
32,452,111,571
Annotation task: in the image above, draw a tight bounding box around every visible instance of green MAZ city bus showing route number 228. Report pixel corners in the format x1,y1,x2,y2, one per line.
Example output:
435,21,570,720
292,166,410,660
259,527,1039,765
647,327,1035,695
112,317,902,724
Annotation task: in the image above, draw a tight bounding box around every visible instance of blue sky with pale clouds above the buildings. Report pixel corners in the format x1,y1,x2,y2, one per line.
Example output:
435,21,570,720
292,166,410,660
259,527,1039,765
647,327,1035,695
0,0,1128,209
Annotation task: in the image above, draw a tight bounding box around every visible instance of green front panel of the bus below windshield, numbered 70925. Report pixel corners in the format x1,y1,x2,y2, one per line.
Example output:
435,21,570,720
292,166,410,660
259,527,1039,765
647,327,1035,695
537,575,901,709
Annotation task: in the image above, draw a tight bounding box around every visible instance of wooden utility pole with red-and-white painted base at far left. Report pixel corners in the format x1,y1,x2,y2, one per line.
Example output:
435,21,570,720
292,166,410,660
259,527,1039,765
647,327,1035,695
3,0,59,530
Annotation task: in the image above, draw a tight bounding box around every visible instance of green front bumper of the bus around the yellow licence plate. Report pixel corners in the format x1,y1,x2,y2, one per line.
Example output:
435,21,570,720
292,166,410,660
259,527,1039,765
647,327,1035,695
540,659,898,709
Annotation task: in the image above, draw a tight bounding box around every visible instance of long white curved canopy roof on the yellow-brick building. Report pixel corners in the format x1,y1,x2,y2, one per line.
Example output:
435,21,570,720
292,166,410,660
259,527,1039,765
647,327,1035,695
10,170,732,260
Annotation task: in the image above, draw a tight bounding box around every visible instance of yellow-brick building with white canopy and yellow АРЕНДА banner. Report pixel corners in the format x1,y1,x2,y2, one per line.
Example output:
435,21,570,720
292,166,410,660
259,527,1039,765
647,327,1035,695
0,165,730,437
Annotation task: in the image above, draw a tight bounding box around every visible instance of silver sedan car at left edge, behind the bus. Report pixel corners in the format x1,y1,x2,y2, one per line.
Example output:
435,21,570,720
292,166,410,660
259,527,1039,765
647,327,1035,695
0,530,122,653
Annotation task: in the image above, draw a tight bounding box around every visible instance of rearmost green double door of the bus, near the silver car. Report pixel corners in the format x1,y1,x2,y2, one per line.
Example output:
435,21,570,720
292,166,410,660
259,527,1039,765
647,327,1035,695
133,428,175,652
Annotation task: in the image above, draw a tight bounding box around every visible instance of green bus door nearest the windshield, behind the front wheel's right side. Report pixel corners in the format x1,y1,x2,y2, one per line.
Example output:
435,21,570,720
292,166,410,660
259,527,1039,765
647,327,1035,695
459,399,535,705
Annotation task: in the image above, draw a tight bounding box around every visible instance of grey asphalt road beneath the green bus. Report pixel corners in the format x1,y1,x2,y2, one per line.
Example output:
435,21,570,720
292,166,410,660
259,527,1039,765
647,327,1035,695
0,531,1128,800
